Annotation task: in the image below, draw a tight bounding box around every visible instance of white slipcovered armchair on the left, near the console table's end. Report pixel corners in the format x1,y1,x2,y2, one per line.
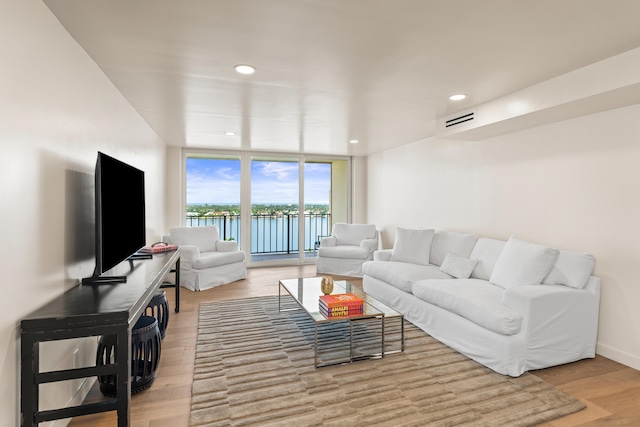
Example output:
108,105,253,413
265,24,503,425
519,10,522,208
165,225,247,291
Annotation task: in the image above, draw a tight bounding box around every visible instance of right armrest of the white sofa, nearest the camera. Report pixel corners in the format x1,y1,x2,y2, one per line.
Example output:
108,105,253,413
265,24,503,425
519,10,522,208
503,276,600,354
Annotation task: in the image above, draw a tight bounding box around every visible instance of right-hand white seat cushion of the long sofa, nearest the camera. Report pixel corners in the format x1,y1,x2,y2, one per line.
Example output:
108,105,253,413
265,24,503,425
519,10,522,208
412,279,522,335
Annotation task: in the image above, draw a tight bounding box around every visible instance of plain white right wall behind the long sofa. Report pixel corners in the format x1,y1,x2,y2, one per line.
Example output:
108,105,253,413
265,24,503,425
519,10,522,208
368,105,640,369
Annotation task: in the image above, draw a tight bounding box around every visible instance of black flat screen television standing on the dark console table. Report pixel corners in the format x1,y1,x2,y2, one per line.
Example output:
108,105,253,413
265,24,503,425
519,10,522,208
82,152,146,284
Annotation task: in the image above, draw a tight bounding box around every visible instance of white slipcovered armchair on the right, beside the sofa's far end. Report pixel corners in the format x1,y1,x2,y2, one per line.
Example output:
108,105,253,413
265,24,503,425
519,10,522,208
316,223,378,277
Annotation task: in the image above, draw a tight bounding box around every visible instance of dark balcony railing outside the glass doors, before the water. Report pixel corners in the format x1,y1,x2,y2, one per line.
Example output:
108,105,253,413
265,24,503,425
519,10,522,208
186,214,331,254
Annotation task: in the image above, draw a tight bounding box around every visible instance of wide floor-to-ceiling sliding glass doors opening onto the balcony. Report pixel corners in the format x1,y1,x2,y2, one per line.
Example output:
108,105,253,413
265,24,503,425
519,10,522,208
185,152,350,265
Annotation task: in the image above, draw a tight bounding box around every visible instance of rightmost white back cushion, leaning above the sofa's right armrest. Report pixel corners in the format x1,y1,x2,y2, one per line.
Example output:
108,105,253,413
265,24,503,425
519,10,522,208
542,250,596,289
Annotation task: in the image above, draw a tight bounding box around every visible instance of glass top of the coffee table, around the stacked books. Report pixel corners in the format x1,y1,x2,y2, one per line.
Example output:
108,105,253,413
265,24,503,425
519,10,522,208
280,277,402,322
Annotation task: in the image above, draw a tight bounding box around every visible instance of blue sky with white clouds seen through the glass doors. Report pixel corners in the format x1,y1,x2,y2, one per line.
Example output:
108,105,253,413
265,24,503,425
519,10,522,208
187,158,331,204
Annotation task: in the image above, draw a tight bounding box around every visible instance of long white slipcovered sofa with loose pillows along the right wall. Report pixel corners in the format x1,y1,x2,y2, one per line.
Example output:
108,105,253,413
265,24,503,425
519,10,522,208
363,228,600,377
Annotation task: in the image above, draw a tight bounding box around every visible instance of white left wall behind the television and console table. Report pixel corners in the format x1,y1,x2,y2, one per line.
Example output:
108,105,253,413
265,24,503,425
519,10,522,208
0,0,165,426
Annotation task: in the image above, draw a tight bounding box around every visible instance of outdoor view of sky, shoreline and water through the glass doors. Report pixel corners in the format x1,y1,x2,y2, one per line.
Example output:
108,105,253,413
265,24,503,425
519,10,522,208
185,155,332,255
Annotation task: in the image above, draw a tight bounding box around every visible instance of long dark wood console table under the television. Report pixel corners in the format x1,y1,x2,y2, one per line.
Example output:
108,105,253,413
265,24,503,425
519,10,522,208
20,249,180,427
